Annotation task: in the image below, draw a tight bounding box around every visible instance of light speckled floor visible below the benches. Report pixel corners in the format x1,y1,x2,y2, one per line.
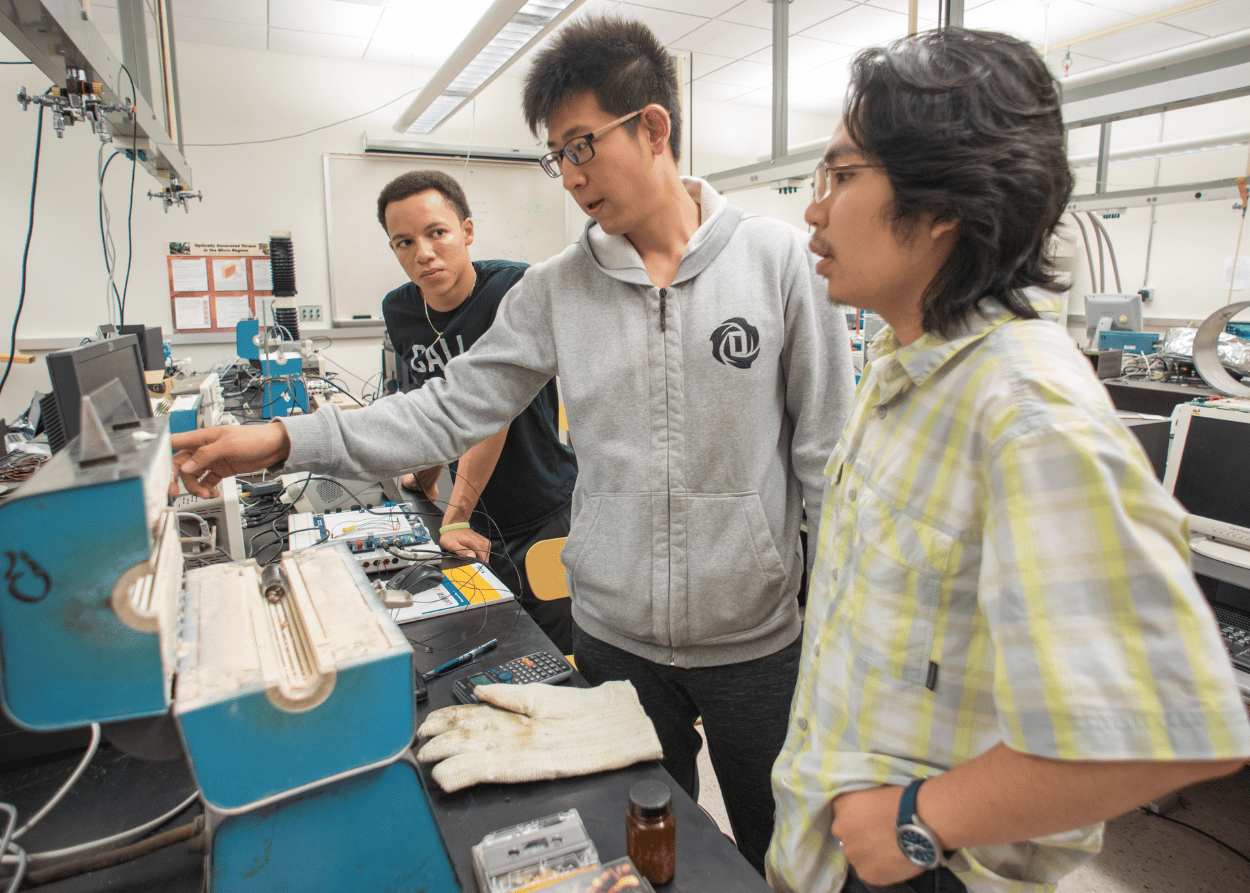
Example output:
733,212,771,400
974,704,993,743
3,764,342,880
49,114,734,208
699,727,1250,893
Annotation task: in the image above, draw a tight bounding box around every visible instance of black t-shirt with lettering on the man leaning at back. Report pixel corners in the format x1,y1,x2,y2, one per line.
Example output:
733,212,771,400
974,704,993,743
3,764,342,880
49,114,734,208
383,260,578,535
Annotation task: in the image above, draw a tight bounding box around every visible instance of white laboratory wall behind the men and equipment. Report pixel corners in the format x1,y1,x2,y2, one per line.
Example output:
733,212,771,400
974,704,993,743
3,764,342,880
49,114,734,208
0,27,1250,419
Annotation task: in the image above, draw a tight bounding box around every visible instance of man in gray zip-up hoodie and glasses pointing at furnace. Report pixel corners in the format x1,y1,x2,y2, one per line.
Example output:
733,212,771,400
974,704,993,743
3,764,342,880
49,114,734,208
174,19,853,872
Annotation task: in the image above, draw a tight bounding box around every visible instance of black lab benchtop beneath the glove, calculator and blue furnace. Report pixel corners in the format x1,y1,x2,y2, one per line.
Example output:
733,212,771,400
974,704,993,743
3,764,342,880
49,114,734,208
0,602,768,893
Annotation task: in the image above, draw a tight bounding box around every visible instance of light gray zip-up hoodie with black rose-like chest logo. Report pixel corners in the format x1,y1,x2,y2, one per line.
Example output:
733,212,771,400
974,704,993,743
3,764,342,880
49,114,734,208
284,179,853,667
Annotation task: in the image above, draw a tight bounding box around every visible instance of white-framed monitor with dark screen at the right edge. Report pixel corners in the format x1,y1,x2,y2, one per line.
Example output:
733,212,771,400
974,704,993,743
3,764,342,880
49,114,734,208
1164,403,1250,549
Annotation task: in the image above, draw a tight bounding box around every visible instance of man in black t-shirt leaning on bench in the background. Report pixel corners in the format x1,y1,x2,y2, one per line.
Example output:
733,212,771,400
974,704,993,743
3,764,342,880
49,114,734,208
378,170,578,654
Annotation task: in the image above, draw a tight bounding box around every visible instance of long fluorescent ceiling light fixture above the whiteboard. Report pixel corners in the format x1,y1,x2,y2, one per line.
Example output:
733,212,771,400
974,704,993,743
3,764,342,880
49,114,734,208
395,0,583,134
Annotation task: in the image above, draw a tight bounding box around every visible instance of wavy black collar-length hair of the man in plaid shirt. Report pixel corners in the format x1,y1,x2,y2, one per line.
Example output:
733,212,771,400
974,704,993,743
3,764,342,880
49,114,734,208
844,28,1073,336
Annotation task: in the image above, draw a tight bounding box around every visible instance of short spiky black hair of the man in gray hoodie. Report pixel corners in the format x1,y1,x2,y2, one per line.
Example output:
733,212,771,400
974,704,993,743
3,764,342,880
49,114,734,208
521,16,681,161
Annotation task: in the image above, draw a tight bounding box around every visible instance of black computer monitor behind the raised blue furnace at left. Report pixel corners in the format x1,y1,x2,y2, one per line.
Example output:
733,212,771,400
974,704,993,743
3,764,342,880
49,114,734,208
44,335,153,450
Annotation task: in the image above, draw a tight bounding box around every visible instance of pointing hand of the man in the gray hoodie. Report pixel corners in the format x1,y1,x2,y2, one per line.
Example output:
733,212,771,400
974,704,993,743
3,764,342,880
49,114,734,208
169,423,291,498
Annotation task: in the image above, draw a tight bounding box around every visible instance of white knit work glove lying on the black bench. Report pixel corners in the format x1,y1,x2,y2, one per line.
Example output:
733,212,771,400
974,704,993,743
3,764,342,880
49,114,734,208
416,682,664,793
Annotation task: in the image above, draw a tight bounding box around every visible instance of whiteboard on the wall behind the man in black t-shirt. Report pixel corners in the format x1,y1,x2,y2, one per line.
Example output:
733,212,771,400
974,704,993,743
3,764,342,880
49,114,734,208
324,154,568,325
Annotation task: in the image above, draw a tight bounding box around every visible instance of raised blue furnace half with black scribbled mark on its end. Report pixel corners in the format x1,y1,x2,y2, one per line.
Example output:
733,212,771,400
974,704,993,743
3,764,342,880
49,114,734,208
0,419,170,732
